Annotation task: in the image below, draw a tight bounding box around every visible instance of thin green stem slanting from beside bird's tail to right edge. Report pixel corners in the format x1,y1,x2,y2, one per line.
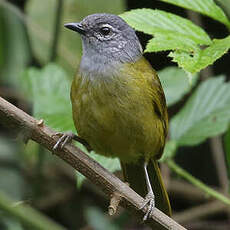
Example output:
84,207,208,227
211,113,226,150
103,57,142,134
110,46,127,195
166,159,230,205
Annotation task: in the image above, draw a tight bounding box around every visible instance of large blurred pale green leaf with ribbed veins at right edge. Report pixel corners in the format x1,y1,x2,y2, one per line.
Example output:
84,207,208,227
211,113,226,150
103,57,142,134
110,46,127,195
170,77,230,145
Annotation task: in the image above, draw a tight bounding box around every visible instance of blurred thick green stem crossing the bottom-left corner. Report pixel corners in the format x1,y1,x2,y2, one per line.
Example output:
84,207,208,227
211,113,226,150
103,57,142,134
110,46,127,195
0,191,65,230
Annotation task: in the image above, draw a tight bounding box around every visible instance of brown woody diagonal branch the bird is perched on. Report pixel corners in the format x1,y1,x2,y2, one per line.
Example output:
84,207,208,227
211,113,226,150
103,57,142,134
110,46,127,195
0,97,185,230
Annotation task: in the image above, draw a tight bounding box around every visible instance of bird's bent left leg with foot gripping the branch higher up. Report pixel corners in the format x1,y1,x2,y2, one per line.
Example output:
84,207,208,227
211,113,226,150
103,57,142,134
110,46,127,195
53,132,92,152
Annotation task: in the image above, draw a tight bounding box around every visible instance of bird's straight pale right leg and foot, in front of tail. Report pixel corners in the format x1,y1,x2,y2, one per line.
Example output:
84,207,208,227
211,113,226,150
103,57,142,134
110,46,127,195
140,161,155,221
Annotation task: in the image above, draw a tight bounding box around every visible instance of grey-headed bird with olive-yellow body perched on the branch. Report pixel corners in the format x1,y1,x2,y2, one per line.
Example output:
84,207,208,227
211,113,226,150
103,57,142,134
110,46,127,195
54,13,171,220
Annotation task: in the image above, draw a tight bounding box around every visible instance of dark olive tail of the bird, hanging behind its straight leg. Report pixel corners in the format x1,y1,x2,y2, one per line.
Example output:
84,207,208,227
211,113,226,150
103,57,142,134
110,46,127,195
121,160,171,216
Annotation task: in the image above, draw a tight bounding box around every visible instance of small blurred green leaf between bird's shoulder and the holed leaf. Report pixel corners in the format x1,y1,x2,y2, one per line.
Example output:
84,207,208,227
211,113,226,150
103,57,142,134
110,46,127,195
158,67,198,106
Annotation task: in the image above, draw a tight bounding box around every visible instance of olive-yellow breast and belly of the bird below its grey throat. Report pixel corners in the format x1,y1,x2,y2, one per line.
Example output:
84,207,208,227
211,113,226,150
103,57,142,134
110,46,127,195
71,58,167,162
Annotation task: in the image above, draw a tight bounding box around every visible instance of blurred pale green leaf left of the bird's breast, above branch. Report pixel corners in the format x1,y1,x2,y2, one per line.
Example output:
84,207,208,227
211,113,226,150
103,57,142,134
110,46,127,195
21,64,75,131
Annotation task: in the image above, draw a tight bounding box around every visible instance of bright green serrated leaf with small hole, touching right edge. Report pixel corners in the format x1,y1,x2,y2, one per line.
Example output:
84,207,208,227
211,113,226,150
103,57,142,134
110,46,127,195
169,36,230,73
